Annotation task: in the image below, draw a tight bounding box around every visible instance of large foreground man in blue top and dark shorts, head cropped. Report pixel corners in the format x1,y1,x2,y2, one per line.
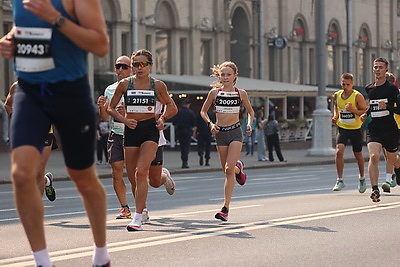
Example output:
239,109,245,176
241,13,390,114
0,0,110,267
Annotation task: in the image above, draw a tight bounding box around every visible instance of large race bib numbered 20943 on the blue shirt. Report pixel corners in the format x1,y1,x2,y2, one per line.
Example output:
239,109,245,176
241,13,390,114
15,27,55,72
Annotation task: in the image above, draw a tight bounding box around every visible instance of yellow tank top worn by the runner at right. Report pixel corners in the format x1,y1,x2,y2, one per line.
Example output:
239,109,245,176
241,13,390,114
336,90,362,130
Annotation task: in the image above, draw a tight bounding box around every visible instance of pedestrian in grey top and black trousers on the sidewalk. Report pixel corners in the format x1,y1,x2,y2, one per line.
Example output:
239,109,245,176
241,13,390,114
264,114,286,162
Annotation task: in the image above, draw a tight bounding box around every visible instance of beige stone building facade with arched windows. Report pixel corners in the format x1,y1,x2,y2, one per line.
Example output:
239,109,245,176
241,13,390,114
0,0,399,119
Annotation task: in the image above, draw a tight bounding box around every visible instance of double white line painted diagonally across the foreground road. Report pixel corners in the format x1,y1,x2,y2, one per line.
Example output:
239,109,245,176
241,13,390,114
0,202,400,267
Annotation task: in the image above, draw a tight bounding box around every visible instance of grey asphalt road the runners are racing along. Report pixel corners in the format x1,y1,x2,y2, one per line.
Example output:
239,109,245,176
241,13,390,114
0,163,400,267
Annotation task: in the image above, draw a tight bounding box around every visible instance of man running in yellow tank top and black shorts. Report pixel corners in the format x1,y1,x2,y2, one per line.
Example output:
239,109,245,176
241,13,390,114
332,73,367,193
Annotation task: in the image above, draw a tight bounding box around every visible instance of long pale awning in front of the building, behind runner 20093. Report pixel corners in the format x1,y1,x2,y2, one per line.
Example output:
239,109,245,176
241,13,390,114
152,74,338,97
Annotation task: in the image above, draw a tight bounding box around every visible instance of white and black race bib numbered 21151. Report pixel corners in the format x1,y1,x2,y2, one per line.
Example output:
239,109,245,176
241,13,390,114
126,90,156,113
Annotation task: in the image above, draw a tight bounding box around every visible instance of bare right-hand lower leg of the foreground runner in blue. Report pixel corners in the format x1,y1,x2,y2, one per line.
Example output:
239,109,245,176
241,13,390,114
67,165,107,248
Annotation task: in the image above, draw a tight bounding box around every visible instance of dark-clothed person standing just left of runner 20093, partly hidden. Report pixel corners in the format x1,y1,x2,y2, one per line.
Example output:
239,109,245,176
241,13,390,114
194,111,215,166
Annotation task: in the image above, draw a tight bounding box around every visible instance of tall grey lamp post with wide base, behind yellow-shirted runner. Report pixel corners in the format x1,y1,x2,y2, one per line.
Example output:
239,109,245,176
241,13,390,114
308,0,335,156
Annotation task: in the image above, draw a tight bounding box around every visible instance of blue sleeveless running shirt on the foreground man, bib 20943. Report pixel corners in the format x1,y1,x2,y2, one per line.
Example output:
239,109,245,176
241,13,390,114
12,0,88,84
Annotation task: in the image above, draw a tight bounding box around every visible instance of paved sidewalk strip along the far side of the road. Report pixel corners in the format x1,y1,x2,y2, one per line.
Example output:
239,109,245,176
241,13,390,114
0,142,368,184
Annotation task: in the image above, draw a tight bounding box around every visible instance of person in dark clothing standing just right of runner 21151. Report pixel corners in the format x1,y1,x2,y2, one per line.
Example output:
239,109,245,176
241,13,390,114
173,98,196,168
